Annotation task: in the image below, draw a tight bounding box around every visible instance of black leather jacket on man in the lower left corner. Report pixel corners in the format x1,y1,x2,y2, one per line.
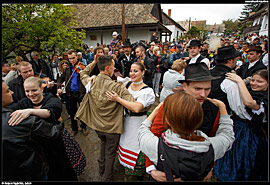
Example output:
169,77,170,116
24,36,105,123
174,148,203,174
2,107,63,181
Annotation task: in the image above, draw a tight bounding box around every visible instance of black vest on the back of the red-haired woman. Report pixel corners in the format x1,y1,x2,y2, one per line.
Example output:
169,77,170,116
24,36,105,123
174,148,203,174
156,136,214,181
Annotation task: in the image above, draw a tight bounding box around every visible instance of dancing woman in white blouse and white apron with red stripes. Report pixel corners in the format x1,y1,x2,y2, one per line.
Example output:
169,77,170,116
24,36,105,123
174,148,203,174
107,62,155,180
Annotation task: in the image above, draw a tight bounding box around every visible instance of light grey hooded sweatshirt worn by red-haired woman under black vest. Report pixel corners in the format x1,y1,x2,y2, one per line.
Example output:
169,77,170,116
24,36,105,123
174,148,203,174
138,115,235,180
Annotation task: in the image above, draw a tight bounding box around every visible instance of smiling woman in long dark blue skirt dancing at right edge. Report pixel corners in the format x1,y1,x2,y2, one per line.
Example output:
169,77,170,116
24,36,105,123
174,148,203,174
214,69,269,181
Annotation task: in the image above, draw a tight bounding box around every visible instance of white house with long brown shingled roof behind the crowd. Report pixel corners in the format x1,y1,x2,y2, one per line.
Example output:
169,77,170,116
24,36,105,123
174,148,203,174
70,3,172,47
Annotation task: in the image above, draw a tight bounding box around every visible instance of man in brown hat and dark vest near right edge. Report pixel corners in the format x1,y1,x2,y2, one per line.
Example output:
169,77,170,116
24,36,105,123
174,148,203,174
236,46,266,84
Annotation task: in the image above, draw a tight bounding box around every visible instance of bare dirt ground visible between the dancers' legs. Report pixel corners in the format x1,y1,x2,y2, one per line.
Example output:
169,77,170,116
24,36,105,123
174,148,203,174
62,98,159,182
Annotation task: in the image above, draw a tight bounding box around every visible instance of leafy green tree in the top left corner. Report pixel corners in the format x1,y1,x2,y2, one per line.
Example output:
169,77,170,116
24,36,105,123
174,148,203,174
2,4,85,61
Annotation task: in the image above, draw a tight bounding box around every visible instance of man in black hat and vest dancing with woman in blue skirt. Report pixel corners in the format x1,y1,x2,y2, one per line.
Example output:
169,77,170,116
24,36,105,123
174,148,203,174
208,46,242,113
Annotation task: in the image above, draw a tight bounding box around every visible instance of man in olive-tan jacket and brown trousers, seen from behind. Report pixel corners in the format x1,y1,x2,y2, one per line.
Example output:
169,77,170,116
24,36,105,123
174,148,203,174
75,55,135,181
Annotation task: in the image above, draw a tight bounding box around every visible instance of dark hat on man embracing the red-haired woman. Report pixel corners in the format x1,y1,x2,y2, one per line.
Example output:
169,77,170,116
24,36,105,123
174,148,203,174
178,62,220,83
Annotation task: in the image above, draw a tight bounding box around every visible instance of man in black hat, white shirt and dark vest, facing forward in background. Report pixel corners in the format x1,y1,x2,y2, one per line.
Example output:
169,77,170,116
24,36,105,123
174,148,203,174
186,40,210,68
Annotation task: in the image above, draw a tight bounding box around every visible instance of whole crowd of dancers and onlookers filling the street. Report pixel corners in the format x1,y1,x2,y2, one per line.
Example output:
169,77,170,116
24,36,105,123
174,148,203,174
2,31,269,181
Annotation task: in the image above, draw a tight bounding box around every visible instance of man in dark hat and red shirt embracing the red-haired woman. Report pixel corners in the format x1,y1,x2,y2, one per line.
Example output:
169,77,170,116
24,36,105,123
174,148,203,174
146,63,224,181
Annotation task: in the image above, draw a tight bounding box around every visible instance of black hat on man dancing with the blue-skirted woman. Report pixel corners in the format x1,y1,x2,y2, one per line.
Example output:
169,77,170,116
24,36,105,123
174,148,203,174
215,46,242,60
